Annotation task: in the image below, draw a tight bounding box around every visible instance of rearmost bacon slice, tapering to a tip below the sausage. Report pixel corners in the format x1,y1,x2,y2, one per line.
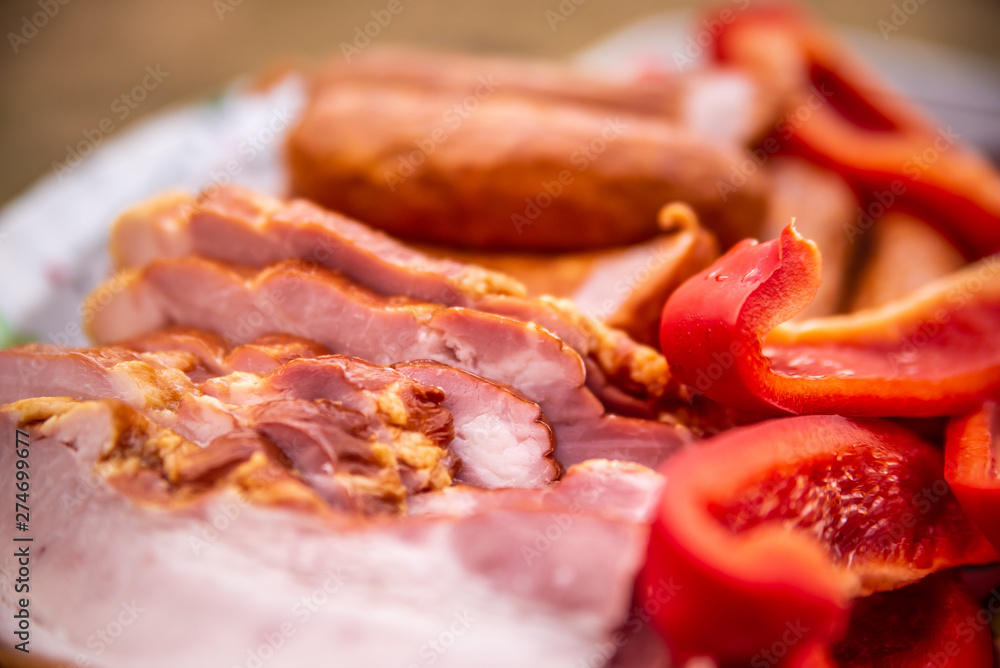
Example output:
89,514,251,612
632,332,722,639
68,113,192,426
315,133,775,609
110,186,524,306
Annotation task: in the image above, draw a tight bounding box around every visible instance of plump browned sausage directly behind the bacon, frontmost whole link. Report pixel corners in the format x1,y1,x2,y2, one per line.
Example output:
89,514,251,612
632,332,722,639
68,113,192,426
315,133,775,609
289,52,766,251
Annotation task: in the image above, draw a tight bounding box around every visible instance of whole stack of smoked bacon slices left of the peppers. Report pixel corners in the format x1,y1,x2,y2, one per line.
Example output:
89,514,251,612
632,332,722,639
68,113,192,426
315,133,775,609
0,180,690,665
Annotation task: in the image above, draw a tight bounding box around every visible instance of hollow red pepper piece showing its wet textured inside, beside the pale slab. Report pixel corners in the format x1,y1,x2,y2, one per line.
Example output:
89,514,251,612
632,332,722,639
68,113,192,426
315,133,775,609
637,415,1000,662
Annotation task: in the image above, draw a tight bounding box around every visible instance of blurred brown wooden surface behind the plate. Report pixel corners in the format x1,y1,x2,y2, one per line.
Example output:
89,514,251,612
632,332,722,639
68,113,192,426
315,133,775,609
0,0,1000,203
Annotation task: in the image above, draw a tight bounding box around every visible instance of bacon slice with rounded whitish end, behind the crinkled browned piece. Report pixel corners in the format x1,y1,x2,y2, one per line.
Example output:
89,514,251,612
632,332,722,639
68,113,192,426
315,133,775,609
0,329,687,486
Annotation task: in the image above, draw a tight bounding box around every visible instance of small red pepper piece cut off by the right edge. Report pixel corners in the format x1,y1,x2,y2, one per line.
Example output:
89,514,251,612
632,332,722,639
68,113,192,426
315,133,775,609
945,401,1000,546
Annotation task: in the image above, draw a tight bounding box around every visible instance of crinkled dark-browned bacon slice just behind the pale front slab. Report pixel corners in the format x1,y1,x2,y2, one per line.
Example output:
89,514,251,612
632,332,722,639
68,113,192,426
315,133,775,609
0,348,460,512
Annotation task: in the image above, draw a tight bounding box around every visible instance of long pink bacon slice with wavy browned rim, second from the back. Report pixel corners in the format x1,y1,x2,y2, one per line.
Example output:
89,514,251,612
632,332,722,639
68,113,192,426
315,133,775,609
91,257,688,464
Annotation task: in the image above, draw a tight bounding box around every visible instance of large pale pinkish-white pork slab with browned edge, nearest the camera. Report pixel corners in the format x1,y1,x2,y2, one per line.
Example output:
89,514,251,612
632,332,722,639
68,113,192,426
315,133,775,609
0,399,658,668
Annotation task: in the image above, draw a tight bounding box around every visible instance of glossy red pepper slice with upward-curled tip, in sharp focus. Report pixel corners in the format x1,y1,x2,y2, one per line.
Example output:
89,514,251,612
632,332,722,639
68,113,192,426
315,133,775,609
660,226,1000,417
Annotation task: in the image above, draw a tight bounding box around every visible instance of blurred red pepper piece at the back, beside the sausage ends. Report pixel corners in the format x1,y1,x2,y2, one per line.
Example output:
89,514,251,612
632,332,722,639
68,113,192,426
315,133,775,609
705,5,1000,259
